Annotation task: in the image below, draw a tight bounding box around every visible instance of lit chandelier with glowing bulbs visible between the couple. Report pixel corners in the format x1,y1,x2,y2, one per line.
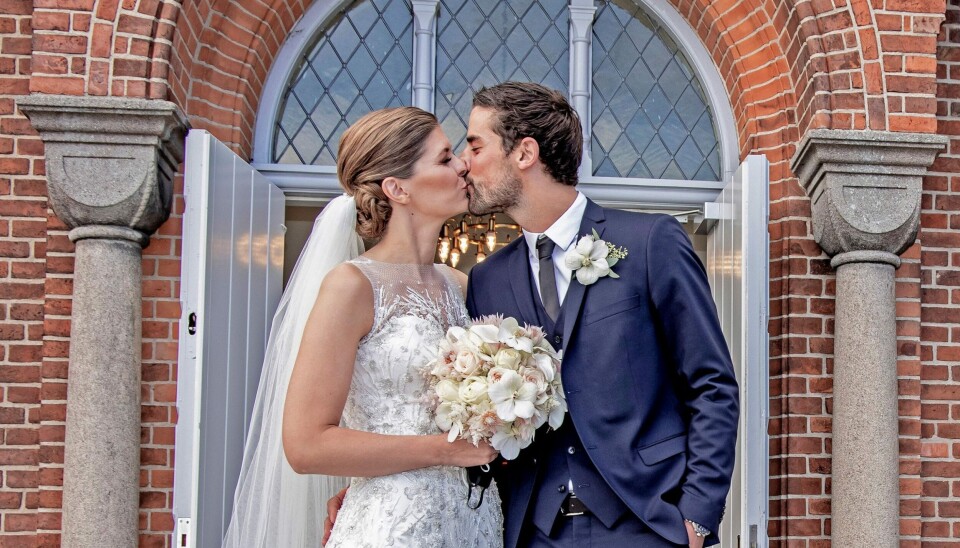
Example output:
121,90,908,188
437,213,520,268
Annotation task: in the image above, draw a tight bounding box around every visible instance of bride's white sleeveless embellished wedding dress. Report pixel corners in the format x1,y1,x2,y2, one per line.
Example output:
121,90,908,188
326,257,503,548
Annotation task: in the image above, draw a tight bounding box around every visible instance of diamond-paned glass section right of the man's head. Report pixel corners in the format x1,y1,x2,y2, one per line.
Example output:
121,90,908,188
591,0,720,181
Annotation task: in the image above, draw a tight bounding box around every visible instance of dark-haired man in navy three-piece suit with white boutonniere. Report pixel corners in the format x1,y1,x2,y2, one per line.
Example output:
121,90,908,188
463,82,739,548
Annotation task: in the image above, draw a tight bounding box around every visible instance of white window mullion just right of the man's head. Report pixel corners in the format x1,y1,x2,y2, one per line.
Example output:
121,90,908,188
570,0,597,177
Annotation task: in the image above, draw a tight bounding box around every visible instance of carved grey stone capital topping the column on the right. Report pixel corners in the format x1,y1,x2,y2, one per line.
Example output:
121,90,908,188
790,129,947,262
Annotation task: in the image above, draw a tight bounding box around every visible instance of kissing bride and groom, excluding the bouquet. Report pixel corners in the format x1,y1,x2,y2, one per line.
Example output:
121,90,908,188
224,82,739,548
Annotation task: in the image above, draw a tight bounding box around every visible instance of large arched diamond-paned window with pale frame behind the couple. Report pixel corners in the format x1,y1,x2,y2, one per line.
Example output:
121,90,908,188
254,0,738,207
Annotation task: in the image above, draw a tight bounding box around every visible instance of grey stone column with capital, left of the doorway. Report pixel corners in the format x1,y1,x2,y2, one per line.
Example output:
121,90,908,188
18,95,186,548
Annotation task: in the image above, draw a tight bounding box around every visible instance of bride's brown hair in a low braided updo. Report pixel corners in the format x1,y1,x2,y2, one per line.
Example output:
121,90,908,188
337,107,439,239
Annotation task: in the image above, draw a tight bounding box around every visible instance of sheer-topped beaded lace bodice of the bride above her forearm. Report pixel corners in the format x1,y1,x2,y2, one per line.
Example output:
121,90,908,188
343,257,468,434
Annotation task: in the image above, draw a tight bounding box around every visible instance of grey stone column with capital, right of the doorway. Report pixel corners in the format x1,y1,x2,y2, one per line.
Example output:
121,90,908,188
791,130,946,548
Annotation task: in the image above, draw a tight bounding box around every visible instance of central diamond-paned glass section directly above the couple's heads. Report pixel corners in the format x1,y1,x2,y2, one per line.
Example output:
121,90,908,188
436,0,570,150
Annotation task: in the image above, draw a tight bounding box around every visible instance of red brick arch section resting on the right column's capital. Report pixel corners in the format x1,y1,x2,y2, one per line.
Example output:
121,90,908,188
783,0,945,135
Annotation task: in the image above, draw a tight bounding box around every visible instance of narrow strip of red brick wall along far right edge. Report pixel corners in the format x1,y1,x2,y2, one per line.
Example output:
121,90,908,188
920,0,960,547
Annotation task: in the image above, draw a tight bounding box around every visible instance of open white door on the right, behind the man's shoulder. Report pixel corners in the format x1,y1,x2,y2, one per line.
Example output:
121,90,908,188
704,156,770,548
